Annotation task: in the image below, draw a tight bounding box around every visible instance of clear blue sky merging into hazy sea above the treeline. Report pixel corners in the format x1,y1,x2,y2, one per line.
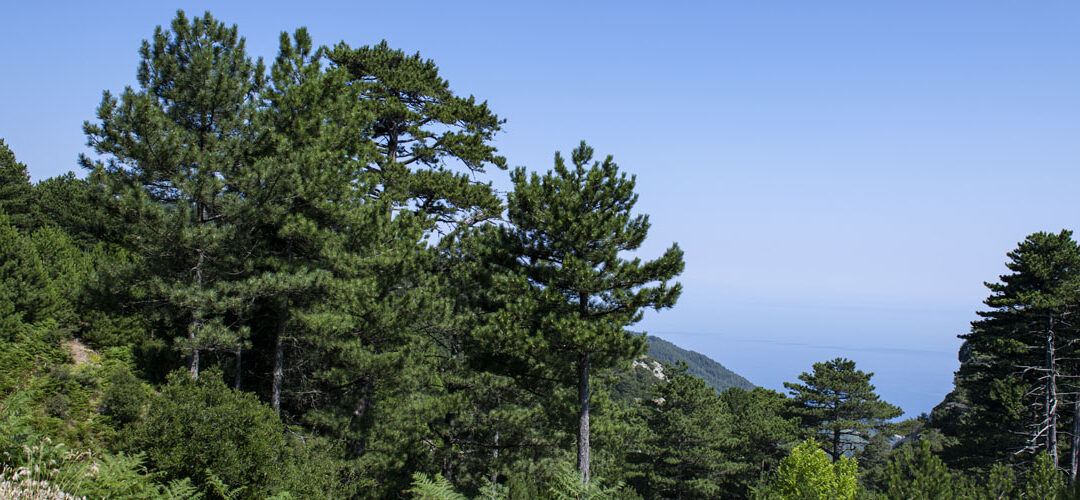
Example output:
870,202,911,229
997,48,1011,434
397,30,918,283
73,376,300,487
0,1,1080,415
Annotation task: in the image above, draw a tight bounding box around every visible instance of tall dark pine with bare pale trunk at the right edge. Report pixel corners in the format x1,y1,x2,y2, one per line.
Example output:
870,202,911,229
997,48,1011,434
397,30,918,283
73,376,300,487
946,231,1080,470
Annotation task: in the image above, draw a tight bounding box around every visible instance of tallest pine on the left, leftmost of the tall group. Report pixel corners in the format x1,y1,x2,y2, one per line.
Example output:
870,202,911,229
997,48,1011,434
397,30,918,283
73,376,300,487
81,11,264,376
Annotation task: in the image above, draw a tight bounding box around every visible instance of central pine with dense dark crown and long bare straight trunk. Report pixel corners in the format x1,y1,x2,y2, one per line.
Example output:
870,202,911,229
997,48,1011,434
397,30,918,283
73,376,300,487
491,141,683,483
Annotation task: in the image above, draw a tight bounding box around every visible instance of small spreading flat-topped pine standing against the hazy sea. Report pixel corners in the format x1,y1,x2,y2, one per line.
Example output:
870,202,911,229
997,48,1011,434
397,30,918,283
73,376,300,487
784,357,904,461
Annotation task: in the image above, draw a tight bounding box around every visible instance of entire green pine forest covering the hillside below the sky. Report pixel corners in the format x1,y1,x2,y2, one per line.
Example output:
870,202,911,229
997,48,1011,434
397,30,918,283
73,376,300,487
0,11,1080,499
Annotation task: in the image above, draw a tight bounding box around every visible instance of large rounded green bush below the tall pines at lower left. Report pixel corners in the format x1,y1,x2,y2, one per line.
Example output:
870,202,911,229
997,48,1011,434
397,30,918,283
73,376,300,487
125,370,339,499
